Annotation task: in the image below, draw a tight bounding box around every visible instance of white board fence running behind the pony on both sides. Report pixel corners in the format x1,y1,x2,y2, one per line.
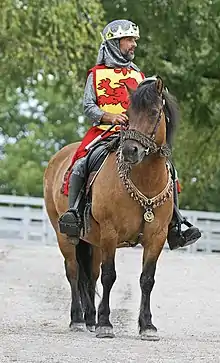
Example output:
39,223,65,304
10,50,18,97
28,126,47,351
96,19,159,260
0,195,220,252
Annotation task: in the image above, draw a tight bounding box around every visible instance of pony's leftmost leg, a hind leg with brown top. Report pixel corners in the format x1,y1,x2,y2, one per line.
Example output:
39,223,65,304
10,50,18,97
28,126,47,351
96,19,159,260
57,232,84,329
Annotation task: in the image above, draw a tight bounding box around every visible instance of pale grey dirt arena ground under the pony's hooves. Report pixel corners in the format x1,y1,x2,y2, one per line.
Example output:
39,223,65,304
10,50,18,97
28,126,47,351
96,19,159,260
0,241,220,363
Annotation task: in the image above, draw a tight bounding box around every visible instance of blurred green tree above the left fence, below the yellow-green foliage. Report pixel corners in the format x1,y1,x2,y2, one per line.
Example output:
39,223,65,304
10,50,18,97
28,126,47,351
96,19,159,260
0,80,86,196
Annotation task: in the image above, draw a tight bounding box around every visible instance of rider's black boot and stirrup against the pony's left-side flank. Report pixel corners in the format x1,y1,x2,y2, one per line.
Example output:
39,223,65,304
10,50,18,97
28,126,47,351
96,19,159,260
59,173,85,238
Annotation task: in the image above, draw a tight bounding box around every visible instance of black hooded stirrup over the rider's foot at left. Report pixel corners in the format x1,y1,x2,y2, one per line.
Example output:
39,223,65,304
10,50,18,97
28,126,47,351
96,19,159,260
59,208,82,238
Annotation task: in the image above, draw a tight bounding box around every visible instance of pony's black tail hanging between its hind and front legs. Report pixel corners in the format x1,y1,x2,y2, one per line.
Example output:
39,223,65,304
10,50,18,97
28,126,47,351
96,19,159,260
76,239,96,312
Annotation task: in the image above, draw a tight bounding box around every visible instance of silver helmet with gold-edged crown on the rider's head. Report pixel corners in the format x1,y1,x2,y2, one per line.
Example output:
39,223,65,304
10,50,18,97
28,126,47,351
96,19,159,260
101,19,140,41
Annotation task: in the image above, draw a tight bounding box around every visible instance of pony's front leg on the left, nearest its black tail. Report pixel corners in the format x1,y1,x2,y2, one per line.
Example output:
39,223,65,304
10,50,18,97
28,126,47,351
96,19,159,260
96,233,116,338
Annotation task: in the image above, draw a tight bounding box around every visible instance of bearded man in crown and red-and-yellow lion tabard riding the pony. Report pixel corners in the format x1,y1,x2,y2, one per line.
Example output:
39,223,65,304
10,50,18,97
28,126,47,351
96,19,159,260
59,20,201,249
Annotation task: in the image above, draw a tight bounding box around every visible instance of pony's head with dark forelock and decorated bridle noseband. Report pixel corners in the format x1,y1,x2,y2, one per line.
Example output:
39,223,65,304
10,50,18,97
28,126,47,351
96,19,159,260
122,76,178,164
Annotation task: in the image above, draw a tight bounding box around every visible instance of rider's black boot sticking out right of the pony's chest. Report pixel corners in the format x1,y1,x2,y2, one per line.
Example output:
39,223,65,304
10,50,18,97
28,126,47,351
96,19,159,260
167,166,201,250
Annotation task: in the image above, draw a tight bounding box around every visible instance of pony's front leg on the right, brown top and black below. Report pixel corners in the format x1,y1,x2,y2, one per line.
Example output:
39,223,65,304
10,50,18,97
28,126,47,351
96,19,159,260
138,236,166,340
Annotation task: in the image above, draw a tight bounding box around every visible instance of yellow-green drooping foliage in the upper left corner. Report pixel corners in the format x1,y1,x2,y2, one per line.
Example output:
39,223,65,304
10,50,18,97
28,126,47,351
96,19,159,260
0,0,102,87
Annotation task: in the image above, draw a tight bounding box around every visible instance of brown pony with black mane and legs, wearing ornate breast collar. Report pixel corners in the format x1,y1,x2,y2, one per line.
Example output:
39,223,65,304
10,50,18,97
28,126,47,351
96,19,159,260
44,77,178,340
